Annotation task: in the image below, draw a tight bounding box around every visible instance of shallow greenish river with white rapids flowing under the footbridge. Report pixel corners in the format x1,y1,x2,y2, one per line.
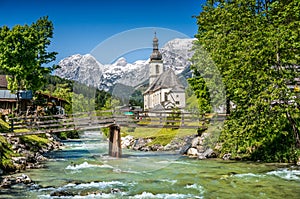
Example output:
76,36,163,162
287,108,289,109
0,132,300,199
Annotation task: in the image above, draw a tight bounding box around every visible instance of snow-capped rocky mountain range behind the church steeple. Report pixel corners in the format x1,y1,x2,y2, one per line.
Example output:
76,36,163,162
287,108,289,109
54,39,194,91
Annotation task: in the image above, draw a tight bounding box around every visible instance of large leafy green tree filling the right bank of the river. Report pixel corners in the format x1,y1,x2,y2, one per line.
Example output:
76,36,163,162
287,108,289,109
192,0,300,162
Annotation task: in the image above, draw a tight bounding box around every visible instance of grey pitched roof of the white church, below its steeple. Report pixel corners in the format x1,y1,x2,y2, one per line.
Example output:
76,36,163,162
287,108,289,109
145,68,184,93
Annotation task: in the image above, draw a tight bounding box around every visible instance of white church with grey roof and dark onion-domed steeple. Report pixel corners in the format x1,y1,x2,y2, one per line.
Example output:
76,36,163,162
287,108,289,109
143,34,185,111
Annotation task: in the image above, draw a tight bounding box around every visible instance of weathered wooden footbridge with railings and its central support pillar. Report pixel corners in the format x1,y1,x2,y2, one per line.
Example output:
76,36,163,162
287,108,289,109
2,110,225,157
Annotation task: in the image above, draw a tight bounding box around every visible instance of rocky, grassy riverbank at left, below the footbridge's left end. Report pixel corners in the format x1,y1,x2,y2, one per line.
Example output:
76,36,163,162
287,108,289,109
0,133,63,188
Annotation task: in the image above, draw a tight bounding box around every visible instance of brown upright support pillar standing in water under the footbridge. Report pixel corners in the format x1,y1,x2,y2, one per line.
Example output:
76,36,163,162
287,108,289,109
108,125,122,158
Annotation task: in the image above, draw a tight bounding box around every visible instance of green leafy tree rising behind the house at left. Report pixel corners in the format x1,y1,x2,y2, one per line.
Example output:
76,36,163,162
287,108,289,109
0,17,57,93
